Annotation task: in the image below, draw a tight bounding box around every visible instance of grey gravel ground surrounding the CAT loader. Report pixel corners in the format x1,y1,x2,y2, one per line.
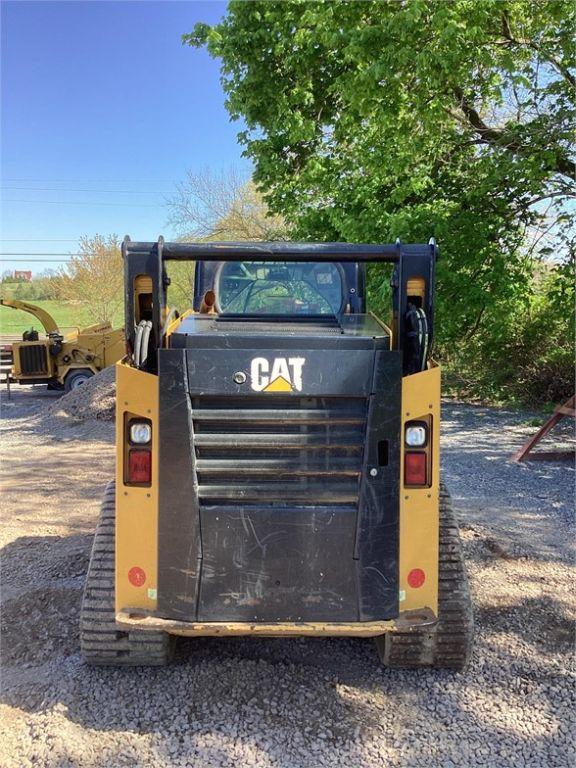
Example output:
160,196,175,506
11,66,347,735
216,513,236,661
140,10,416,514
0,390,576,768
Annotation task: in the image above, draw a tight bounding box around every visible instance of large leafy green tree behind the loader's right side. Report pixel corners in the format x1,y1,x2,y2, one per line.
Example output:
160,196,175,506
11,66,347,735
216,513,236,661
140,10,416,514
184,0,575,408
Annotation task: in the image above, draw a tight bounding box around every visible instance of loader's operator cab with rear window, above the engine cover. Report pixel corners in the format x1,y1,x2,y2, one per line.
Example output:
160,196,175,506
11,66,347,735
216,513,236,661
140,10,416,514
169,261,390,349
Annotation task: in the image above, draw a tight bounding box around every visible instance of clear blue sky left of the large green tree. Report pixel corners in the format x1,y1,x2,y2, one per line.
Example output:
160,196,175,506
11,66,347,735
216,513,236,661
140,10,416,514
0,0,248,272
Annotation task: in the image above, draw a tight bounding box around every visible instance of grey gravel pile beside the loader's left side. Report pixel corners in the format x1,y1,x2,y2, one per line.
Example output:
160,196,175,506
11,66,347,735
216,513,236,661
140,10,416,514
46,365,116,421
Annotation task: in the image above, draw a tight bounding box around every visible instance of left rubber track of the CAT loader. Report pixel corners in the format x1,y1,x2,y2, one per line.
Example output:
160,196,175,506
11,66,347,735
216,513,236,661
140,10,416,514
80,482,175,667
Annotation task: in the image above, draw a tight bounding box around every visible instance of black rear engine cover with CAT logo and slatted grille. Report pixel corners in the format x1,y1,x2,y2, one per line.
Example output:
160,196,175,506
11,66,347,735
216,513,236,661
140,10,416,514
158,316,402,622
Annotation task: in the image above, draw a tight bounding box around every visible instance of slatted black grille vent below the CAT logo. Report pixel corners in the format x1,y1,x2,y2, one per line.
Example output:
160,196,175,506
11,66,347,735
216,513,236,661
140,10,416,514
192,396,367,506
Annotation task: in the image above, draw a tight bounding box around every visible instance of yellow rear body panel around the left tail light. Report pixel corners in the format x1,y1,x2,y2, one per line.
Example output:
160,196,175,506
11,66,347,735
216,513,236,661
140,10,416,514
116,362,158,610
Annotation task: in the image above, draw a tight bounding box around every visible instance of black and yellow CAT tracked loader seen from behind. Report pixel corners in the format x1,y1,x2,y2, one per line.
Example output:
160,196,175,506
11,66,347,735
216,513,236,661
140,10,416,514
81,238,473,669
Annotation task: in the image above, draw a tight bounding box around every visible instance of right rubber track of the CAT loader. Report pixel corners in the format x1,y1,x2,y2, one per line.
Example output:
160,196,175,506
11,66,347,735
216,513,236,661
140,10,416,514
376,484,474,670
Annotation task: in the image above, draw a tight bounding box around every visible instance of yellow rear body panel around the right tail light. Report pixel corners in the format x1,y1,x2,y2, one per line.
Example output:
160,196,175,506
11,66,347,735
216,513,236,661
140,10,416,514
399,367,440,615
